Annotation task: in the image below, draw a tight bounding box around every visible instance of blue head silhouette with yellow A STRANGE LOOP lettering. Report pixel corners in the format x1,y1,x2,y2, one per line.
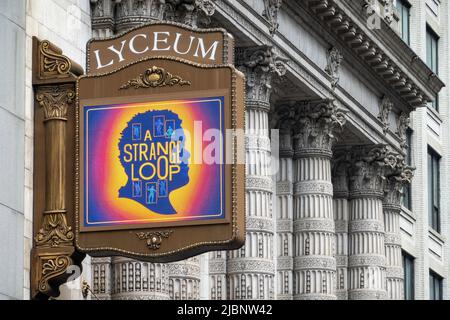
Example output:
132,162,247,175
118,110,190,214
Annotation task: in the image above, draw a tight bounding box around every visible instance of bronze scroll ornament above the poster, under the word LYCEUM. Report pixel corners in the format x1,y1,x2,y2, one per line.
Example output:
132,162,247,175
120,66,191,90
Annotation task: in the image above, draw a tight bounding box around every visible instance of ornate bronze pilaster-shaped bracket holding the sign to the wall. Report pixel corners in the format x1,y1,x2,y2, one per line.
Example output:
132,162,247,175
31,37,84,299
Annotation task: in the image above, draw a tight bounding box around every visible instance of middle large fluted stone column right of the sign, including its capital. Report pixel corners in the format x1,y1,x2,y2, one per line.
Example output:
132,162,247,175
294,100,345,300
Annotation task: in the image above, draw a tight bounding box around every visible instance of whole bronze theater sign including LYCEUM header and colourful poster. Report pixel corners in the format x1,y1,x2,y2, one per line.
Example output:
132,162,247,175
34,23,245,295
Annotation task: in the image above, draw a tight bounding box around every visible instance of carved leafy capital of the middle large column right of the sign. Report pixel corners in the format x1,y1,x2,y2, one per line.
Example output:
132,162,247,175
294,100,346,158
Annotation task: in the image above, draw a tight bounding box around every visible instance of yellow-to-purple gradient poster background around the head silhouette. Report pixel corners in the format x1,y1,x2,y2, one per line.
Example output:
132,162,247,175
81,97,225,227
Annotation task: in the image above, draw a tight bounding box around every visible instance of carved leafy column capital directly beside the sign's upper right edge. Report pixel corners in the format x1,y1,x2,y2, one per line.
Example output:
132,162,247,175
236,46,287,112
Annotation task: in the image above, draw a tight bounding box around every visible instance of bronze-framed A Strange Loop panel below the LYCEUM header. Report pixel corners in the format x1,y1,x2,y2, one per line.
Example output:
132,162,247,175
74,58,245,262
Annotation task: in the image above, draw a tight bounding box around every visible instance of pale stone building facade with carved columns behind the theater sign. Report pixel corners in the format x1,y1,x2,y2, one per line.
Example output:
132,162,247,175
0,0,450,300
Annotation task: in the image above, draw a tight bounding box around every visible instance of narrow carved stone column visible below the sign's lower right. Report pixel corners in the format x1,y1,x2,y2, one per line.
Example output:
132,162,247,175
167,256,200,300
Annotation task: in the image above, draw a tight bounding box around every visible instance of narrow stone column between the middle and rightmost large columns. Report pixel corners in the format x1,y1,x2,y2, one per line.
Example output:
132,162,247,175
332,148,350,300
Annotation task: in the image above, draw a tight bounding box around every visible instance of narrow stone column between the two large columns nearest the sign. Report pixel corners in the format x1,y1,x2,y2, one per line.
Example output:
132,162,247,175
272,106,295,300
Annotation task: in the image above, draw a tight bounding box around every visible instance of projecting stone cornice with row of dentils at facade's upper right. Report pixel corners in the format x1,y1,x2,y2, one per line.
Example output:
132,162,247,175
301,0,444,109
